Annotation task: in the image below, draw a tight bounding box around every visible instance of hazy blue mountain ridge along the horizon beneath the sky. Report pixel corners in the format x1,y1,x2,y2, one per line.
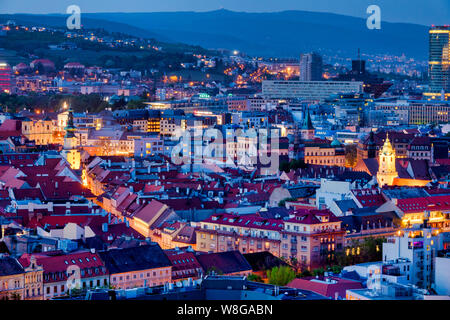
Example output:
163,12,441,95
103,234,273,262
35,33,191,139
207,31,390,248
0,10,428,59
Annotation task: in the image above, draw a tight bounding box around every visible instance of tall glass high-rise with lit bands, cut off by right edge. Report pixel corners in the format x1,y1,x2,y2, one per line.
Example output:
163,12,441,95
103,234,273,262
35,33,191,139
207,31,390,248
424,26,450,100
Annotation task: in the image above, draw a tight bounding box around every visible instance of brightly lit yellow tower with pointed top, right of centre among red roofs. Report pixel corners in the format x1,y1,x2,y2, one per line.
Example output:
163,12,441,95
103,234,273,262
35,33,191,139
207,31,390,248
377,133,398,187
